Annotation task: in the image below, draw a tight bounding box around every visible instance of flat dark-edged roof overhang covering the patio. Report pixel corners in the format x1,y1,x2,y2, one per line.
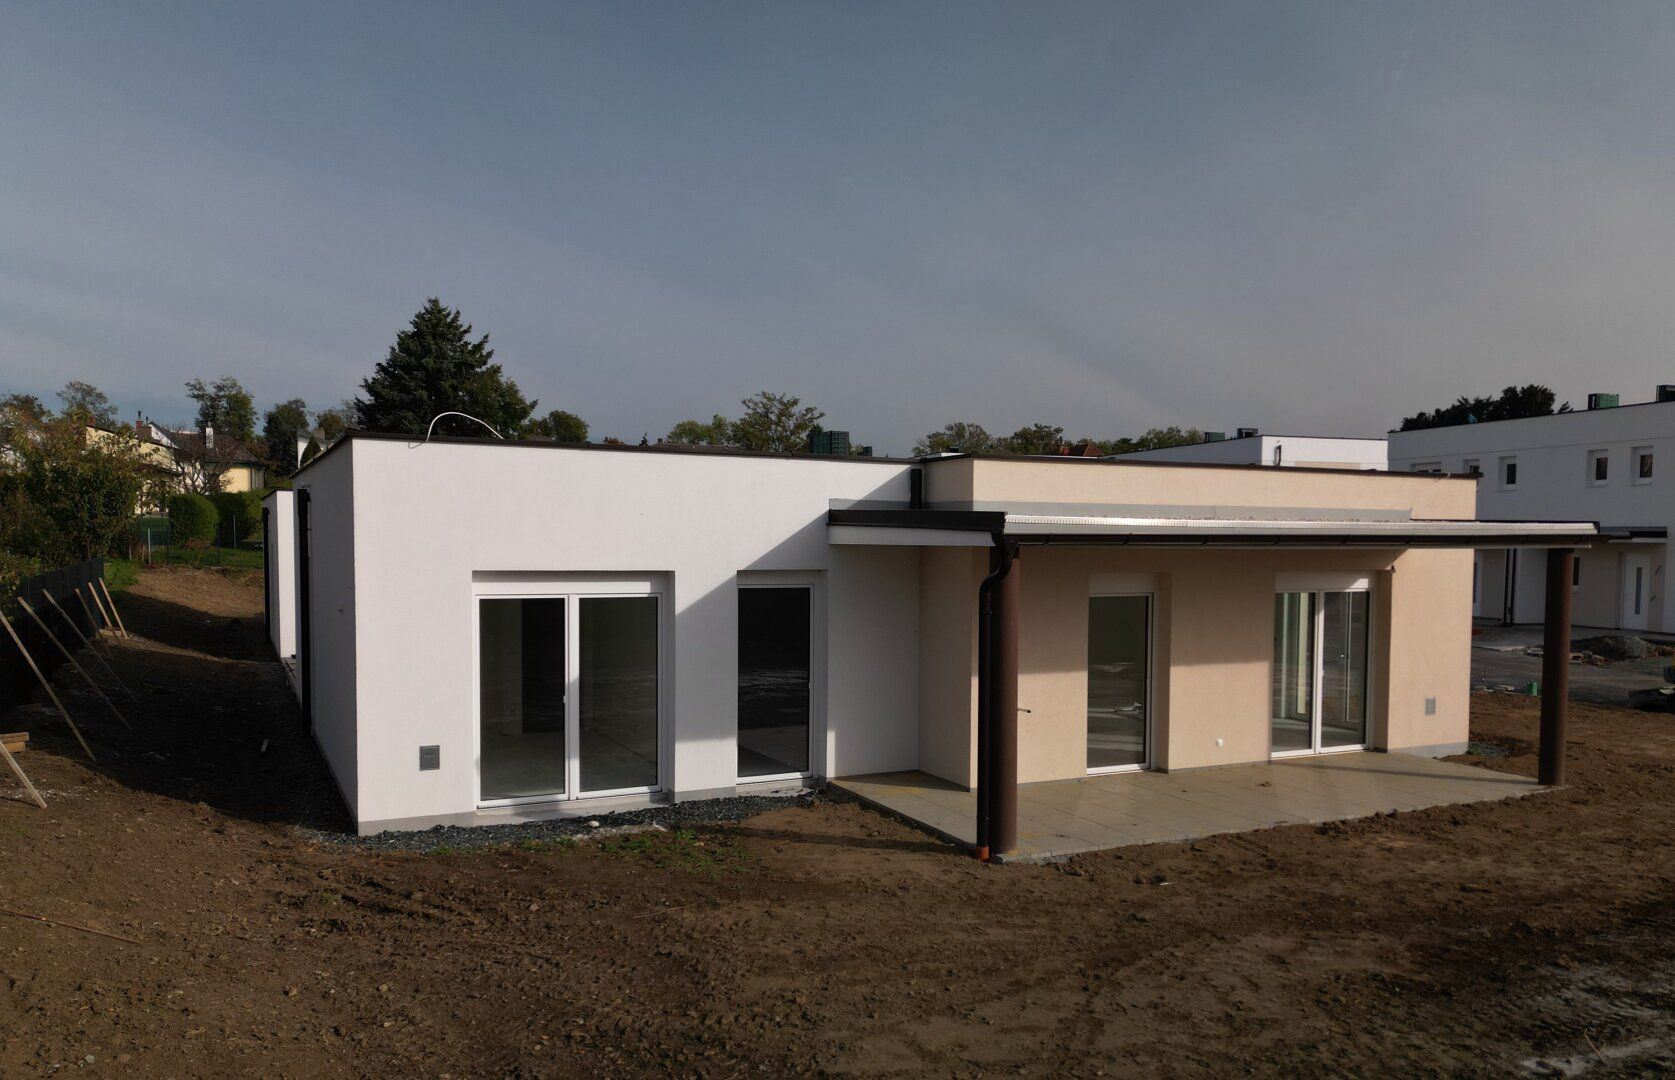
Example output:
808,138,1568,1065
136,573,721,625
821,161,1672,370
826,506,1601,548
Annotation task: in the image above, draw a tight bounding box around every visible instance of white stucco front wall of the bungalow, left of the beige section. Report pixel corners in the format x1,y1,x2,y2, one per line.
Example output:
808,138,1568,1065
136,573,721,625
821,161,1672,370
333,439,920,829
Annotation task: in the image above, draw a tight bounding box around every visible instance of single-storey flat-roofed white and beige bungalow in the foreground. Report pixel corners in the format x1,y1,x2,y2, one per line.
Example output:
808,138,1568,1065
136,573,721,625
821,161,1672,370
266,432,1593,851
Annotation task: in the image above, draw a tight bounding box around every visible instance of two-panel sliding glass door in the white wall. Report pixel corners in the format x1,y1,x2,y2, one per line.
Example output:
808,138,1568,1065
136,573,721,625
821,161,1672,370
477,594,662,805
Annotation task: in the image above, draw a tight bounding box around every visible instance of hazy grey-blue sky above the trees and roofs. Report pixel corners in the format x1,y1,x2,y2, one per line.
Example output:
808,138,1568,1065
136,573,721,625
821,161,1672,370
0,2,1675,452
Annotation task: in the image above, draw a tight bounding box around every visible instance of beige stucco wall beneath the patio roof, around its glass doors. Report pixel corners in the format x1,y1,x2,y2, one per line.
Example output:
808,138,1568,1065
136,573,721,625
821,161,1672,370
920,548,1472,785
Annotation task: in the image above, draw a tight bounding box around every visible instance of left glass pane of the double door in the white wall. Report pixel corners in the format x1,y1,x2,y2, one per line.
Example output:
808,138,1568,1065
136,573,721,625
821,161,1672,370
477,598,564,799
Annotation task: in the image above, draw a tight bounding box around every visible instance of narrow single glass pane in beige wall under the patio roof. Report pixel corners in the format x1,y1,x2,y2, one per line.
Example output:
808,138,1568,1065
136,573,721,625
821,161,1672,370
1087,596,1151,769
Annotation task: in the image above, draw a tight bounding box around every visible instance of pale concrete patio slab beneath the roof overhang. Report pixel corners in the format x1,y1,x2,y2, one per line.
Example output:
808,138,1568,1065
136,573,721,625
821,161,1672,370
832,752,1546,861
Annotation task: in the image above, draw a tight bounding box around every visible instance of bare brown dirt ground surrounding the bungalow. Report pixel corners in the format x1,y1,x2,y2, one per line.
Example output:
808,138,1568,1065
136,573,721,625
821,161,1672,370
0,571,1675,1077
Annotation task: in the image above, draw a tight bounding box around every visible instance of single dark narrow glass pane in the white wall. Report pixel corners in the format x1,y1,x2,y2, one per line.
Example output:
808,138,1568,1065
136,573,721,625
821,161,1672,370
739,586,812,777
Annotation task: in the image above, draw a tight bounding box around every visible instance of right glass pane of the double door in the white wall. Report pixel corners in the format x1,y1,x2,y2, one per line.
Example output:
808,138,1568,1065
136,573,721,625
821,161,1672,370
578,596,658,792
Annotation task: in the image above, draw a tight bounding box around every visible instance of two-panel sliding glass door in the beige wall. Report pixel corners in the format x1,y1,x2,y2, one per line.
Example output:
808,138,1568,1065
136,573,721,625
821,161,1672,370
1270,589,1372,757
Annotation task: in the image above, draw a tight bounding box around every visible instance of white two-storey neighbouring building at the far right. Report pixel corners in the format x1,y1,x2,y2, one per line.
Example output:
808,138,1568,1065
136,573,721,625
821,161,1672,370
1390,387,1675,633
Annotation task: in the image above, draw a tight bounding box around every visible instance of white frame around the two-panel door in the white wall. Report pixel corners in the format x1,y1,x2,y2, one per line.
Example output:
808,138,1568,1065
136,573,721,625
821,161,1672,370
471,573,675,810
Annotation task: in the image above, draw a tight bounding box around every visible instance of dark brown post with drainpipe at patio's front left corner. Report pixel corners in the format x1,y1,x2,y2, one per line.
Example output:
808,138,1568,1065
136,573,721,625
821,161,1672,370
977,532,1018,862
